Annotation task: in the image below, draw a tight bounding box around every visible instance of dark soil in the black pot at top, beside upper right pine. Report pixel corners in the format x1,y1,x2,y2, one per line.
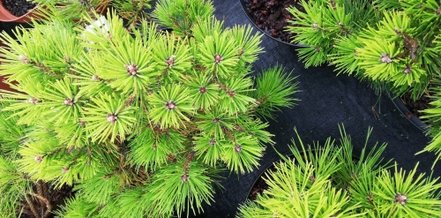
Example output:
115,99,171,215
244,0,300,43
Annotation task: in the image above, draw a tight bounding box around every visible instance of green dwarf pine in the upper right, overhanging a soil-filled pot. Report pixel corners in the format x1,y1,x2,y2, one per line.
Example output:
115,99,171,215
287,0,441,166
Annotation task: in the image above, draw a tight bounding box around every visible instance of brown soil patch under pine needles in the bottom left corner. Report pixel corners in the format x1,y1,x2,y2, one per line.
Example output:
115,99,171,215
20,182,74,218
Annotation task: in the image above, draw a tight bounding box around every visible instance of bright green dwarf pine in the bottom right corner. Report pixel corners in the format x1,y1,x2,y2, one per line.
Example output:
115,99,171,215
237,128,441,218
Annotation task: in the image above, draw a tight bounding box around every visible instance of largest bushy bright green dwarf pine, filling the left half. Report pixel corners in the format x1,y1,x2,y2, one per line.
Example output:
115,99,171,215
0,0,297,217
